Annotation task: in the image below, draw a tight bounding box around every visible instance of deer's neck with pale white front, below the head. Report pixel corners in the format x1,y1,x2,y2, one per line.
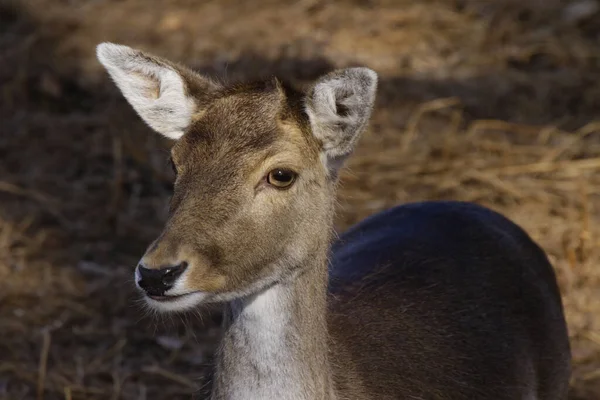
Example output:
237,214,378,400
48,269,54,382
213,252,335,400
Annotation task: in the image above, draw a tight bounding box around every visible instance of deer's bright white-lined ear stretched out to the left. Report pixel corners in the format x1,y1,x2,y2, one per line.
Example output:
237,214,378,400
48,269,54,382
97,43,217,139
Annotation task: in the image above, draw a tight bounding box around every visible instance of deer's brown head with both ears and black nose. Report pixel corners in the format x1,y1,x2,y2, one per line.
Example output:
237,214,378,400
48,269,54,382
97,43,377,311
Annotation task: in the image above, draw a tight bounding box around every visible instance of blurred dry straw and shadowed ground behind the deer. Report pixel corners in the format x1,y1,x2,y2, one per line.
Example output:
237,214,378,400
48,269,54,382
0,0,600,400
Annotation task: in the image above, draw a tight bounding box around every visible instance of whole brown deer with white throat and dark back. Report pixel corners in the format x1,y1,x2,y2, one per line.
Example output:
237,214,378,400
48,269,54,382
98,43,570,400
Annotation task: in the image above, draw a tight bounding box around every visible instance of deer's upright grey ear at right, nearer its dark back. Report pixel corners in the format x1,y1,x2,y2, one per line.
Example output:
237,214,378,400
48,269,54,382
306,68,377,176
